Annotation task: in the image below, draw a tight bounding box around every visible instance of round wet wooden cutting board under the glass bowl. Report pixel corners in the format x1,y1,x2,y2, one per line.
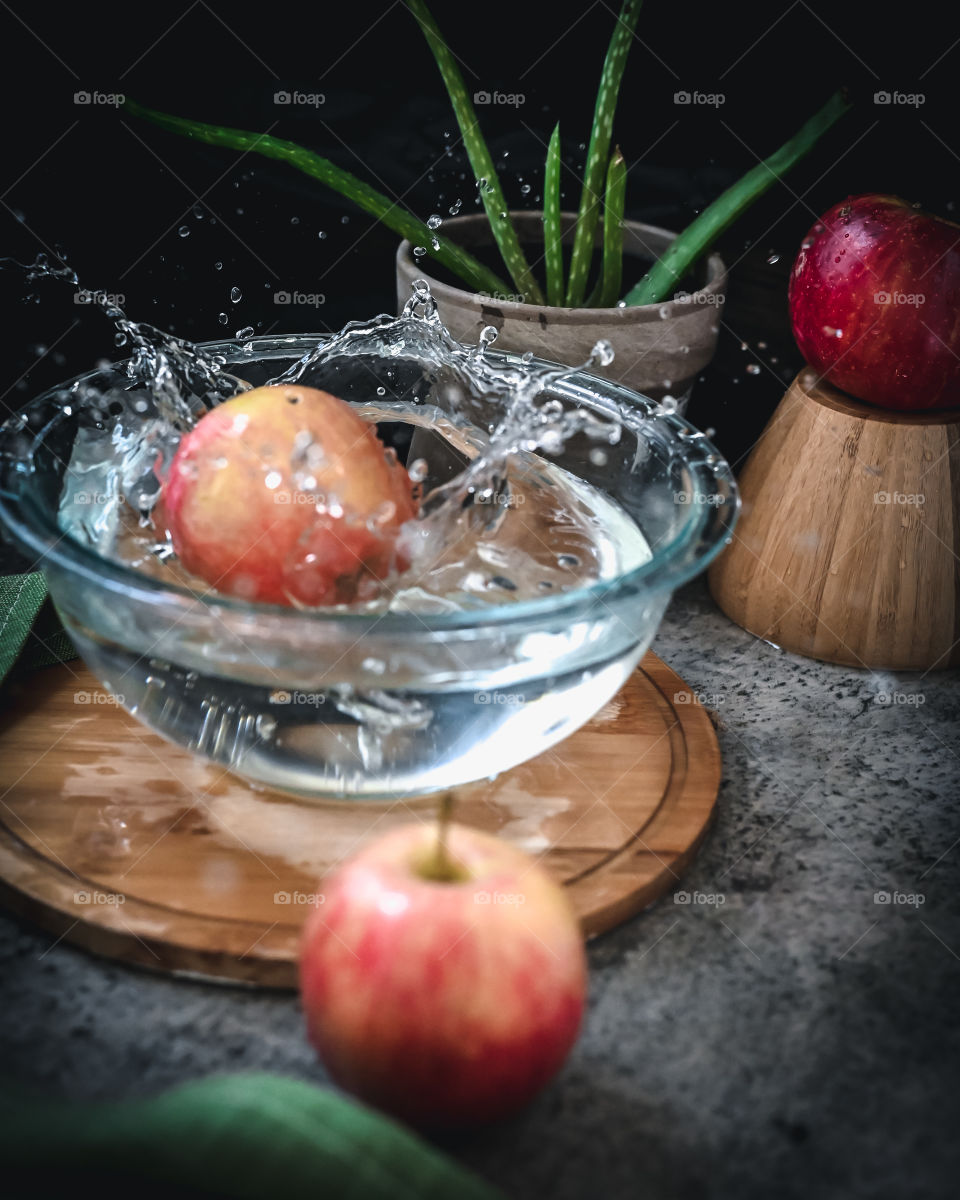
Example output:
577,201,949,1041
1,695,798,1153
0,653,720,988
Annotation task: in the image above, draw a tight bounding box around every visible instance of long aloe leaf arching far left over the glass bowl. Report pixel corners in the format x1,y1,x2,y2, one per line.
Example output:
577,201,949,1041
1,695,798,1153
124,100,510,300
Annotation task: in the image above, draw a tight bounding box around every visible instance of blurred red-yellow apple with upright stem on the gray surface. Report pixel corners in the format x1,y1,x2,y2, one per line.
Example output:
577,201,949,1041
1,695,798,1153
300,823,587,1128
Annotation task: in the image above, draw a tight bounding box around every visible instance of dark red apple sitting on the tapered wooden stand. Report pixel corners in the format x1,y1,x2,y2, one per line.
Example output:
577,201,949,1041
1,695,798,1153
790,196,960,410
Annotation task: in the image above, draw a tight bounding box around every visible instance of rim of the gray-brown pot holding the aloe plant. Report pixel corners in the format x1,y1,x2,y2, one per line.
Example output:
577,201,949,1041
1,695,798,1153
396,209,727,325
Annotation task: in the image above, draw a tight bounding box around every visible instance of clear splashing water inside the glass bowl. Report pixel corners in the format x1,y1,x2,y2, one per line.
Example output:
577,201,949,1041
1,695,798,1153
7,271,666,798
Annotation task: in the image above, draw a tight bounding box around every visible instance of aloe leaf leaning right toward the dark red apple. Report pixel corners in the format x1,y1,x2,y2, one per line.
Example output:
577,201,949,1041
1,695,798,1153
624,91,850,305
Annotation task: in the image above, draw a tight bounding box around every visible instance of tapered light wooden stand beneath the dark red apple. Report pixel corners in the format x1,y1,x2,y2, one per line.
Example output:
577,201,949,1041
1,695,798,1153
709,367,960,671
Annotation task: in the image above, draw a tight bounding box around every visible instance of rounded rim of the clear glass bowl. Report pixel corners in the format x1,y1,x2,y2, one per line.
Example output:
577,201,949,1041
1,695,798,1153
0,334,740,634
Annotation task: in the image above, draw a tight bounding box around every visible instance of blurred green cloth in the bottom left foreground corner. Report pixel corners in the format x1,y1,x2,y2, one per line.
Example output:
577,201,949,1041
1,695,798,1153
0,1075,503,1200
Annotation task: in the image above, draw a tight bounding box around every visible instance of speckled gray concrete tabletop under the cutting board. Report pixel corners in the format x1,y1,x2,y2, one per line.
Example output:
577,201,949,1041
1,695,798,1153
0,582,960,1200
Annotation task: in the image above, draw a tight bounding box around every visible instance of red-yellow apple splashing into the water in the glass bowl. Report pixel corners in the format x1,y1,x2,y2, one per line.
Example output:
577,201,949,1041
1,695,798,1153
154,385,416,605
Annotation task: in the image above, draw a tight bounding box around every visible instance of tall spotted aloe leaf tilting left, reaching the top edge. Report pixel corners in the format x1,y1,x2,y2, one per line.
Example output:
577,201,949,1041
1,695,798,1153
406,0,544,304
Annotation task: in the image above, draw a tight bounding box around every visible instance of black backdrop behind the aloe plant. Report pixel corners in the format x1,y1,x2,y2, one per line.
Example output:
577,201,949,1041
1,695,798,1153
0,0,960,549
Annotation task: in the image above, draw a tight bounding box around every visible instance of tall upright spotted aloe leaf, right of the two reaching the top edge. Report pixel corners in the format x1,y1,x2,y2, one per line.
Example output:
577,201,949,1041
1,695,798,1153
566,0,642,308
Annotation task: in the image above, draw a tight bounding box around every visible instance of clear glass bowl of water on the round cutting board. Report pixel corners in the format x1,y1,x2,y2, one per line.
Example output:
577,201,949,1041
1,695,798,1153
0,335,739,800
